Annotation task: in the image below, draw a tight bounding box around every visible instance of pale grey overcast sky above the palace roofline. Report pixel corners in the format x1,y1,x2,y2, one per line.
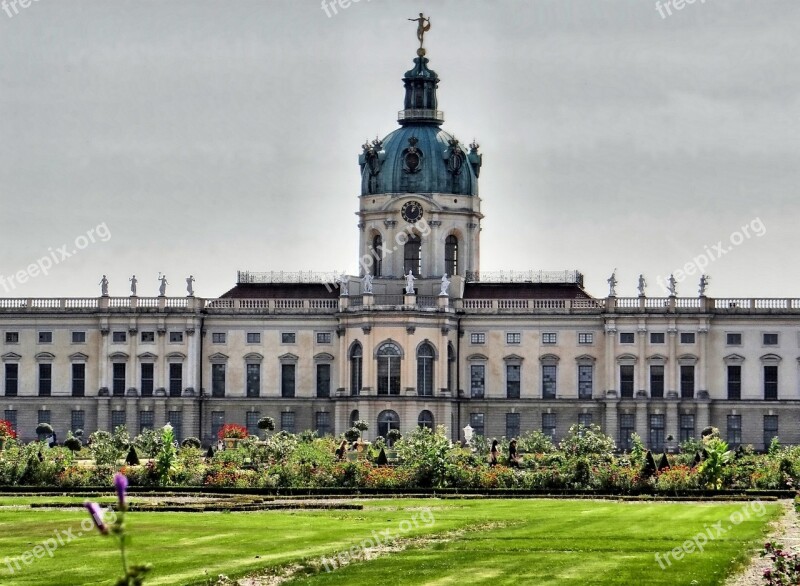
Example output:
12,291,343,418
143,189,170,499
0,0,800,297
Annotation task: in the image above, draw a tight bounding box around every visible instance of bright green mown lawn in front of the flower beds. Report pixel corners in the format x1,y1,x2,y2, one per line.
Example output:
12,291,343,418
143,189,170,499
0,496,779,586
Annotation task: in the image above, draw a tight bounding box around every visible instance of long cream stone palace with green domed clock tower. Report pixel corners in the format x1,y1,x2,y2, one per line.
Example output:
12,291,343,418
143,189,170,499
0,35,800,450
